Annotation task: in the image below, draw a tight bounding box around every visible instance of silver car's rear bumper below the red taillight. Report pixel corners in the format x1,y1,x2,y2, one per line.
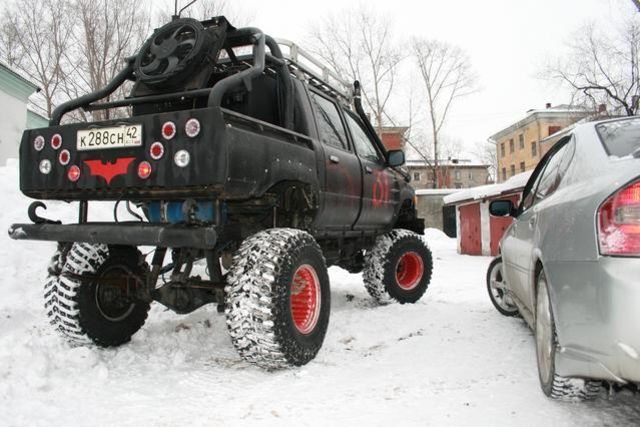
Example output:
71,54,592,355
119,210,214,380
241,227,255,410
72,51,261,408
545,257,640,383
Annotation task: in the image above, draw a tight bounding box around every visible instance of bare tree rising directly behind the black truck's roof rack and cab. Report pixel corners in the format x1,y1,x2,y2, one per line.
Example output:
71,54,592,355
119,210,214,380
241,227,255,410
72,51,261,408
309,6,402,133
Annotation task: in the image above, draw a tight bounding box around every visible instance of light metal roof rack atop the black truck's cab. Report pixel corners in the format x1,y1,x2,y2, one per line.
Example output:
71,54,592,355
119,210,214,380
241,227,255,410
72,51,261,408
275,39,353,105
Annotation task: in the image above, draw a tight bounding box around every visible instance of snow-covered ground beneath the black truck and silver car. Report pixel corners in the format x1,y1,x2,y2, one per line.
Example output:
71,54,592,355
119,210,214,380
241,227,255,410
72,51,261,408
0,164,640,426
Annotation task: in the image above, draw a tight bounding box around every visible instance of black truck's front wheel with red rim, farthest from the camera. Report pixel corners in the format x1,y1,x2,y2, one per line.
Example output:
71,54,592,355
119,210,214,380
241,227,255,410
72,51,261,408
362,229,433,304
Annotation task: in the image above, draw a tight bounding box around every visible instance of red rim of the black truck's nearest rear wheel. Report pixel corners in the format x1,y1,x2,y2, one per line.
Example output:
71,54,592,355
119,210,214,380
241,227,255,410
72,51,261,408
291,264,321,335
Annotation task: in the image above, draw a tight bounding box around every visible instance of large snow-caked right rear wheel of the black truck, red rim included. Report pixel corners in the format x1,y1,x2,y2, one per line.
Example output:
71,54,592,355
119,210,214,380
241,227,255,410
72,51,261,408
225,228,331,370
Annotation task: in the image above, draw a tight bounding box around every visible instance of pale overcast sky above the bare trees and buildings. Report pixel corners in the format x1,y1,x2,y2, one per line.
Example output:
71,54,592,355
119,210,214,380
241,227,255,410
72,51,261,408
204,0,637,159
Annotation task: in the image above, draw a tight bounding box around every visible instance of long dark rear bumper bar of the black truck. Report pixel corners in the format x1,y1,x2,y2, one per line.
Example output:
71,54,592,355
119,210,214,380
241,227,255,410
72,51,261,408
9,222,218,249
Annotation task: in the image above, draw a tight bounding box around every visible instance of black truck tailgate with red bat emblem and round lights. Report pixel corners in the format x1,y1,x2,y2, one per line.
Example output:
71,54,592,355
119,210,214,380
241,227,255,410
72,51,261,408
20,108,227,200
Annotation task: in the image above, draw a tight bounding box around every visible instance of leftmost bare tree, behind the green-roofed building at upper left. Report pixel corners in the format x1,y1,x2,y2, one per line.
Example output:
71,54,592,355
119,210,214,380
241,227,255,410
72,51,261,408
0,0,73,115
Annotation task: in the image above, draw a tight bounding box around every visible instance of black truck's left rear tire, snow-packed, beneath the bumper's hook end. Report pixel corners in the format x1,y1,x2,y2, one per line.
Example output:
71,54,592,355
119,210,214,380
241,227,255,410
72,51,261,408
44,243,150,347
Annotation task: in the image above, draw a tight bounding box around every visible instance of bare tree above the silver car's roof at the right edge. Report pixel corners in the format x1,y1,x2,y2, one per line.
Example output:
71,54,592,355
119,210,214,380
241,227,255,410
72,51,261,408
544,14,640,116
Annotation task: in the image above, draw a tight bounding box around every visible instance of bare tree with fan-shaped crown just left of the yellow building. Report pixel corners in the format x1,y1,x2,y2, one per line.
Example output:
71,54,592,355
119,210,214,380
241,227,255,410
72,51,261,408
411,38,476,188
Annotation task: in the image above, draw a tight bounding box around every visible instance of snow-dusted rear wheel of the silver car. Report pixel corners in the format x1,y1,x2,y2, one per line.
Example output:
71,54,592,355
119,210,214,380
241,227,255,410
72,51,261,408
535,271,602,401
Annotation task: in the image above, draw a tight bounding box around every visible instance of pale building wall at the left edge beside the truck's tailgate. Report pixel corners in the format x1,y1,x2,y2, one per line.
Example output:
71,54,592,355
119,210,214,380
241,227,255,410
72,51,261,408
0,91,27,166
